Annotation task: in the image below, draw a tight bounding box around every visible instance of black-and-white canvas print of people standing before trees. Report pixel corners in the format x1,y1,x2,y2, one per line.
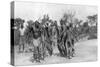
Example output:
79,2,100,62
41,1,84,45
10,1,98,66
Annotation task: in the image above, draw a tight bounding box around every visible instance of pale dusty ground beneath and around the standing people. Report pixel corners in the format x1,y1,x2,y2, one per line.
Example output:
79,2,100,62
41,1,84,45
15,39,97,65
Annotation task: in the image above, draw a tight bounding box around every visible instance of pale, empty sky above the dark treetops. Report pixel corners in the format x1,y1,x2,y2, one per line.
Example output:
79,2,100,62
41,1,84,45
14,2,98,21
